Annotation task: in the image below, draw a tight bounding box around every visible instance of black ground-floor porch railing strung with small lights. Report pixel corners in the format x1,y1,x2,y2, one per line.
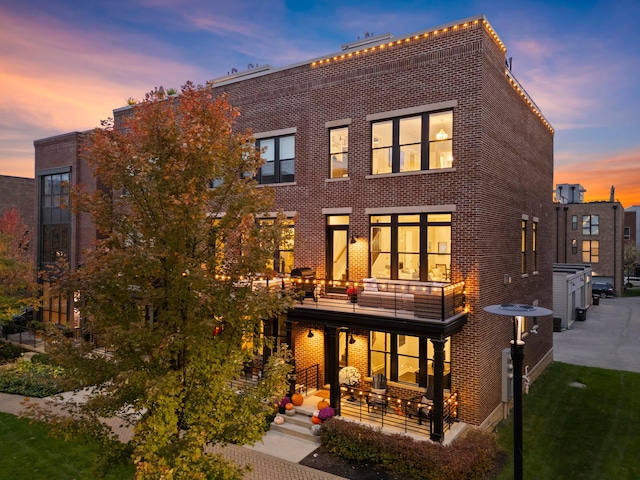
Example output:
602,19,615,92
340,387,459,436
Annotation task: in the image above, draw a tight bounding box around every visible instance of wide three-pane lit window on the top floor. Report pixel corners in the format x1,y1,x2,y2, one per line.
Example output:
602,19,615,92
371,111,453,175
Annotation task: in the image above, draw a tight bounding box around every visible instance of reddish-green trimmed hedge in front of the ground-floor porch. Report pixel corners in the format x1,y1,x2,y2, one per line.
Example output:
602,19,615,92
321,418,500,480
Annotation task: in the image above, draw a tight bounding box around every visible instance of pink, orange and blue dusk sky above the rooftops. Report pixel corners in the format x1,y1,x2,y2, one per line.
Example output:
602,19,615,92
0,0,640,207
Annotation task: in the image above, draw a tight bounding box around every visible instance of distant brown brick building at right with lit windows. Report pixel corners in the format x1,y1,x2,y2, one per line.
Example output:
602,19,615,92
554,184,625,295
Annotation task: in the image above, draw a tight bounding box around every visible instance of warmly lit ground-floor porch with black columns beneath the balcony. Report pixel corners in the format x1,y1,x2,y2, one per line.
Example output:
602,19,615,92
285,284,467,442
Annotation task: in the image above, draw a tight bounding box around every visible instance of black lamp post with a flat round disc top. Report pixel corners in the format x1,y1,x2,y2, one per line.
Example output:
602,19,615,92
484,303,553,480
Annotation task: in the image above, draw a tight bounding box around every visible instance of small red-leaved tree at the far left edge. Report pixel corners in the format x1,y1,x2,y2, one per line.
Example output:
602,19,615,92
0,208,38,323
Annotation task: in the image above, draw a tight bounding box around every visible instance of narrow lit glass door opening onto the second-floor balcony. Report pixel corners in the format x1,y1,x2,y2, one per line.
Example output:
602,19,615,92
326,215,349,293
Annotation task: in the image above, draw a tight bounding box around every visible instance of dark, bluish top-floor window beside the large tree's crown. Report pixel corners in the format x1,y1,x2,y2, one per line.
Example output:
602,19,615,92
258,135,295,184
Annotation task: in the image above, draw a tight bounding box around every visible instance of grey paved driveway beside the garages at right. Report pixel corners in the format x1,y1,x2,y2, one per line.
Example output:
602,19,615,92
553,297,640,372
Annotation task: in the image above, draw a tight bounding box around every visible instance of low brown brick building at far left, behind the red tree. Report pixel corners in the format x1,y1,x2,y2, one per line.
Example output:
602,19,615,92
0,175,37,258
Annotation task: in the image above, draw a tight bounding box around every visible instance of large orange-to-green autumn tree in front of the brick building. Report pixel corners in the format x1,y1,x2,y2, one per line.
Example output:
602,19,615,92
41,83,290,480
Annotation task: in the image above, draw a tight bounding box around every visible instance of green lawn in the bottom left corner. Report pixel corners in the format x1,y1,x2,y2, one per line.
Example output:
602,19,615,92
0,413,134,480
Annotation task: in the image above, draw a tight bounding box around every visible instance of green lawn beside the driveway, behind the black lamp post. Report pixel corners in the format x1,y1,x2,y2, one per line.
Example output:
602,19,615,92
497,362,640,480
